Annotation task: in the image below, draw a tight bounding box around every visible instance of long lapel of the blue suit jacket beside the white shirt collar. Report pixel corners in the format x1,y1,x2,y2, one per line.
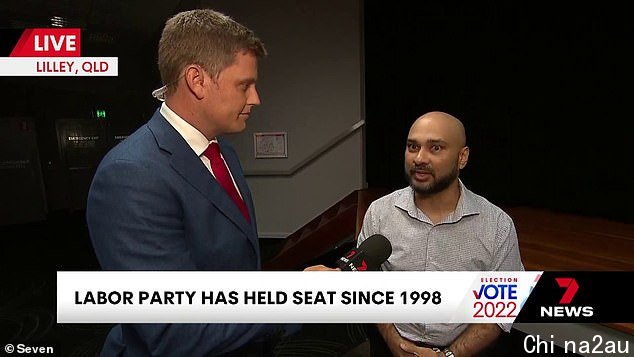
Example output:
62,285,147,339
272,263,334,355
148,110,259,248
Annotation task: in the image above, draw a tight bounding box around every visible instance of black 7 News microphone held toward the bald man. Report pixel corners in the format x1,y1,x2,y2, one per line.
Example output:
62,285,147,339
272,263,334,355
337,234,392,271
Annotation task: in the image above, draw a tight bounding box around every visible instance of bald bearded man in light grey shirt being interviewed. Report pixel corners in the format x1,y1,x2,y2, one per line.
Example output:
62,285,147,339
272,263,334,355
358,112,524,357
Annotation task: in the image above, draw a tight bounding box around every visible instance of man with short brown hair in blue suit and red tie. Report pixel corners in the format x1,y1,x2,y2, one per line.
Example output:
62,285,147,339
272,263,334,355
86,10,276,356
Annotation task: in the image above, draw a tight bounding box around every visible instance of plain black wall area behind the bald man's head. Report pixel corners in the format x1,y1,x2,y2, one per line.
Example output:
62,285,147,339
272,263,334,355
365,2,634,222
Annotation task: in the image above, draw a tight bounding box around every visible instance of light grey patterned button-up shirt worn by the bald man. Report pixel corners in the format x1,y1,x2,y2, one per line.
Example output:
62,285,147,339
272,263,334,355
358,182,524,346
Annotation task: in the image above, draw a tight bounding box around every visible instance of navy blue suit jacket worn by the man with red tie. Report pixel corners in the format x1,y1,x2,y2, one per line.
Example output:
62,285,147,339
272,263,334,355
86,110,276,356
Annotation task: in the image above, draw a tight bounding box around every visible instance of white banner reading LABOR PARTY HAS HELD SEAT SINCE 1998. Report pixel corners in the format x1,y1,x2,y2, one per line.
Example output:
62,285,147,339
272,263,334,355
57,271,542,323
